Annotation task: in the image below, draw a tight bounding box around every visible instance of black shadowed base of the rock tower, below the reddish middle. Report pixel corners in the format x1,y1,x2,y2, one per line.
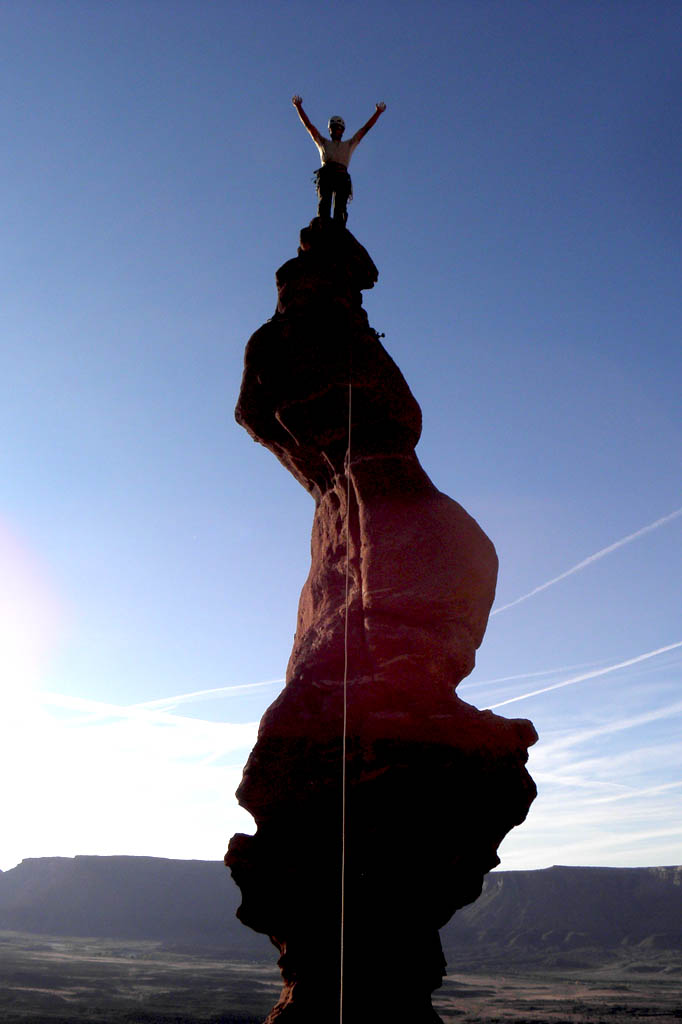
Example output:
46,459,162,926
225,696,536,1024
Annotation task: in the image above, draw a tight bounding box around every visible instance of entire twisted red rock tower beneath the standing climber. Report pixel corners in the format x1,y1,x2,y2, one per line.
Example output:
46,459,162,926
225,220,537,1024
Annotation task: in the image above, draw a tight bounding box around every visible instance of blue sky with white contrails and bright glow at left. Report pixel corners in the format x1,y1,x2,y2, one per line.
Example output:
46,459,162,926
0,0,682,868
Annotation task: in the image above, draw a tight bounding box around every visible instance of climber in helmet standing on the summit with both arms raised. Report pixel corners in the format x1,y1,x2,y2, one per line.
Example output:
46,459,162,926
292,96,386,224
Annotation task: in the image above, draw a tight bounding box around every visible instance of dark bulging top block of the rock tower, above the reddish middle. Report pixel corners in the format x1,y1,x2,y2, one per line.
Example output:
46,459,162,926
236,220,422,499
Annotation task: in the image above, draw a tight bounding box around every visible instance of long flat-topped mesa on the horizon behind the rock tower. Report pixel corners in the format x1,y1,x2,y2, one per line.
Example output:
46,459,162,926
0,856,682,958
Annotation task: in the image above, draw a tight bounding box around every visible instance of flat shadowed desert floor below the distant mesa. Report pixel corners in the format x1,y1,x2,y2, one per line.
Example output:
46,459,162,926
0,932,682,1024
